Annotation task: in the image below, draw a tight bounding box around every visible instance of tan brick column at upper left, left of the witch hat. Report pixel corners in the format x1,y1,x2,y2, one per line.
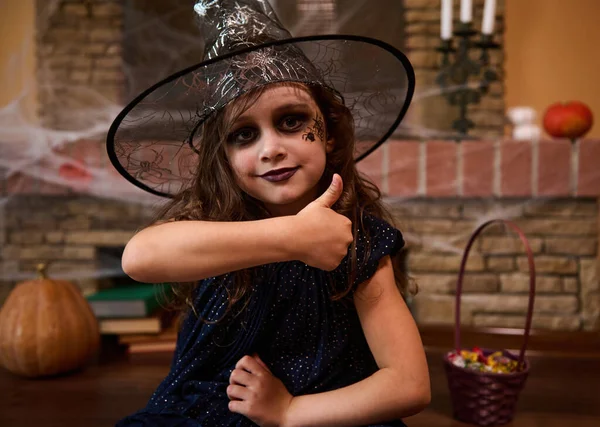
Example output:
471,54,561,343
36,0,124,129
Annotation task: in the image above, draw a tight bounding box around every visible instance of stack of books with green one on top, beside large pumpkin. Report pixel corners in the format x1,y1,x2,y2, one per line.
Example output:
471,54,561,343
87,283,177,353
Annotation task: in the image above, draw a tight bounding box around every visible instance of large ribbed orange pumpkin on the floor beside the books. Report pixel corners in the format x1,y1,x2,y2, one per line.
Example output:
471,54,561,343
0,264,100,378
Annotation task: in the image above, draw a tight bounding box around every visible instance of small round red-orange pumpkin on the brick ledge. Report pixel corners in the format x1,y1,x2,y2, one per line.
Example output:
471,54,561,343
544,101,594,139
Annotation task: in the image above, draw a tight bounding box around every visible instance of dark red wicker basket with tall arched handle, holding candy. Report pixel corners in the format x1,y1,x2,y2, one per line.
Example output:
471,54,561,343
443,219,535,426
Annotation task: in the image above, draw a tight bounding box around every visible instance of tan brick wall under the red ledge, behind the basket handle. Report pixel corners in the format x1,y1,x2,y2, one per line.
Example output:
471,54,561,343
392,199,600,330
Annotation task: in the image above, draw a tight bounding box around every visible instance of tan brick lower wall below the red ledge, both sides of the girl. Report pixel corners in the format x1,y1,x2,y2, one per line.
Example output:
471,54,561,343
0,183,600,330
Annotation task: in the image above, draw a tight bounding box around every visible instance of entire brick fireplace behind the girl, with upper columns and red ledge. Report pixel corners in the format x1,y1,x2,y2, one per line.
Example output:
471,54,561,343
0,0,600,331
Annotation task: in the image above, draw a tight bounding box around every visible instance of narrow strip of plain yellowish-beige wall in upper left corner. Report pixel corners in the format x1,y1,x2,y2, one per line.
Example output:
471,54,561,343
0,0,36,120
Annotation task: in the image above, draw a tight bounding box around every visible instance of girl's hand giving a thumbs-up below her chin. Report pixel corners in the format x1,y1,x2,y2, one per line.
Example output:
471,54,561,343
290,174,353,271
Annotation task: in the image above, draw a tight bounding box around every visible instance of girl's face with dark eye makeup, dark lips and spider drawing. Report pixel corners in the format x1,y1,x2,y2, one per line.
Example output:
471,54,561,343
226,85,334,216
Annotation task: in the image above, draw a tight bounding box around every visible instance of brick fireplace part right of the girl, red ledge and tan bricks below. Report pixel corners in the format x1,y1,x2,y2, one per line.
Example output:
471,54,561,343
359,139,600,330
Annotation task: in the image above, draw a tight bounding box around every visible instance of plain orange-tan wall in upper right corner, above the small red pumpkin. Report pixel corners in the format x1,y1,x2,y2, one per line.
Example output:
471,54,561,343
505,0,600,138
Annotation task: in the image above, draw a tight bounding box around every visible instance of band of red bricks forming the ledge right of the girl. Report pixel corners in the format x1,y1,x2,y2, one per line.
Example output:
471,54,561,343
358,139,600,199
